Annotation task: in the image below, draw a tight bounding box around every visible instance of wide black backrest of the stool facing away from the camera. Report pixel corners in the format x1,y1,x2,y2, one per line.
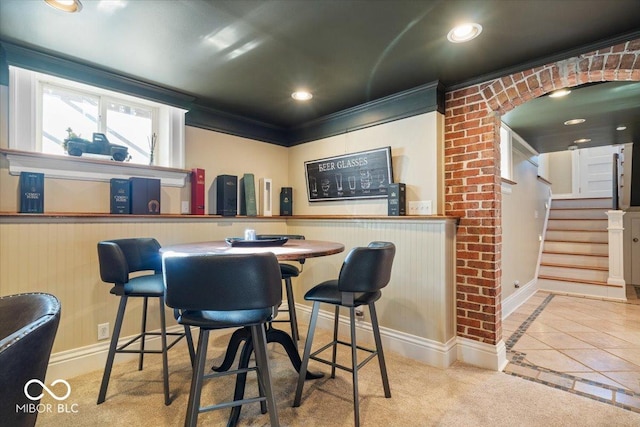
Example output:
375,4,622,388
163,252,282,311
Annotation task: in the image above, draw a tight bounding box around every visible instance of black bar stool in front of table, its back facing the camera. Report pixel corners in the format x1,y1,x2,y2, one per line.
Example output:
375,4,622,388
163,252,282,427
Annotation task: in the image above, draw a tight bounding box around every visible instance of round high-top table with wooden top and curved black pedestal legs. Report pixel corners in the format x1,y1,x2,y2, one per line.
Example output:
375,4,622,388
160,239,344,426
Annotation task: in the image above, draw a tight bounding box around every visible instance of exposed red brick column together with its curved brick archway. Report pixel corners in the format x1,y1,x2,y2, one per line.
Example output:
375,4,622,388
445,40,640,344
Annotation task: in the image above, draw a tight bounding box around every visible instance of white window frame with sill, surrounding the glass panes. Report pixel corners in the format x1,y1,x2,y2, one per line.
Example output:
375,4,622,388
5,66,188,187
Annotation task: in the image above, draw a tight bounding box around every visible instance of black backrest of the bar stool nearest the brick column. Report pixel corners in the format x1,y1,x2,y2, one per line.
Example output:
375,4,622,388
338,242,396,292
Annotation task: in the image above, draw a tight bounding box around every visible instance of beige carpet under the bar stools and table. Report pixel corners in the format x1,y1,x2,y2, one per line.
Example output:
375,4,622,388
37,327,640,427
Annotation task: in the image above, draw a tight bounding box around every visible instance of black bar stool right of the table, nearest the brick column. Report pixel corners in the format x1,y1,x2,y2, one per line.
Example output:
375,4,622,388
293,242,396,426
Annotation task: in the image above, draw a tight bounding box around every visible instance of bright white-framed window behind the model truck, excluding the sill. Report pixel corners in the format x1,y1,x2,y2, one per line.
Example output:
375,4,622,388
9,66,186,172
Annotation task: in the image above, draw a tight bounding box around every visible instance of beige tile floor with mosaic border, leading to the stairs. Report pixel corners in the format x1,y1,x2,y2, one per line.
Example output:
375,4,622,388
502,288,640,412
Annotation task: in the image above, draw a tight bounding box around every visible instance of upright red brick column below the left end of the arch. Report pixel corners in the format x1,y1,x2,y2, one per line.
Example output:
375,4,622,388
445,86,502,344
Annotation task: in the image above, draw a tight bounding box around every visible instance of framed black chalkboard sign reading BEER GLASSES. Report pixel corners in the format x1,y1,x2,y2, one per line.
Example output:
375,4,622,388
304,147,393,202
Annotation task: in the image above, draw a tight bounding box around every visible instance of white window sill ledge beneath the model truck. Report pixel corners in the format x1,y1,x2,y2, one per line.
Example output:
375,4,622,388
0,149,191,187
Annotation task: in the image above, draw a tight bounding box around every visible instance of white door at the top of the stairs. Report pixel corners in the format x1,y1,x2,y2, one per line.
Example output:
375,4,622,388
578,145,620,197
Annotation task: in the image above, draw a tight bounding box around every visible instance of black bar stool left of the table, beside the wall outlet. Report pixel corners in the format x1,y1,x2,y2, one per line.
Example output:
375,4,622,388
98,238,195,405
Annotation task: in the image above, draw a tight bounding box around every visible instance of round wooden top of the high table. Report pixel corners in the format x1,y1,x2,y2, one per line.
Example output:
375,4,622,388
161,239,344,261
